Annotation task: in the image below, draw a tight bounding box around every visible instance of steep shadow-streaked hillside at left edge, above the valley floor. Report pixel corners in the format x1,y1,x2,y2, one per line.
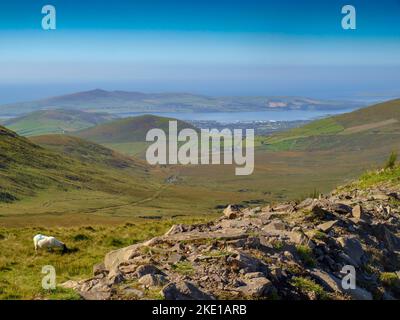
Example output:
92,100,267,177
0,127,157,202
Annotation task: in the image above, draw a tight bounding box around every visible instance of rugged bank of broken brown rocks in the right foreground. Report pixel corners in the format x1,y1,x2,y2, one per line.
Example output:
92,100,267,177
63,170,400,300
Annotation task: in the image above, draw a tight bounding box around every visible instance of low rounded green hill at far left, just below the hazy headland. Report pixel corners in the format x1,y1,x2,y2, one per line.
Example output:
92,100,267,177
3,109,114,136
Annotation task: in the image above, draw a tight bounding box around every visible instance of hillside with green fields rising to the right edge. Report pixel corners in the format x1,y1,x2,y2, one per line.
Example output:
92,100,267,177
262,100,400,151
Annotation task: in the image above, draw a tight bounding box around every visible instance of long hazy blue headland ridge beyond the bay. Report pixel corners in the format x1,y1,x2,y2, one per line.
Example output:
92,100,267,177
0,89,360,115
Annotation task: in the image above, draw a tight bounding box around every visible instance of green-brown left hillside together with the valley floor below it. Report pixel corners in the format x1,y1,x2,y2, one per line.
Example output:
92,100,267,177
0,128,246,227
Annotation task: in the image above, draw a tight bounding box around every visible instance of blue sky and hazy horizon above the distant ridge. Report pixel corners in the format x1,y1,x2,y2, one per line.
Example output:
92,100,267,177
0,0,400,103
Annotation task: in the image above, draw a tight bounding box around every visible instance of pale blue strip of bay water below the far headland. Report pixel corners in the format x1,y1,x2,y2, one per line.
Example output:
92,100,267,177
118,109,354,123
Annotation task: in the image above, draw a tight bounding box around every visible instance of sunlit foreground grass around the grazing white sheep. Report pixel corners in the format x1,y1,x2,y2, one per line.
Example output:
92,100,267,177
0,216,215,300
